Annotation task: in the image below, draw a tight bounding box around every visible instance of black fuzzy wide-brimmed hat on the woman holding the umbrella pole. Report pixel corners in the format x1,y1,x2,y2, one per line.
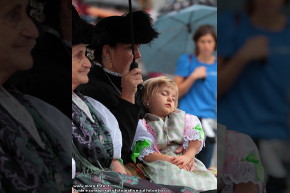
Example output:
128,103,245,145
95,11,159,63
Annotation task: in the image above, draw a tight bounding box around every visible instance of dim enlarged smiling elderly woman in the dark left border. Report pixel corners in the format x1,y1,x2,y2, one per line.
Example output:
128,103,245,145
0,0,71,193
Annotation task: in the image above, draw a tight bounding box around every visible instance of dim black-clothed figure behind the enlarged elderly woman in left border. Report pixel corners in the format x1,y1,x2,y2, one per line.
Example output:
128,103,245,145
9,0,71,117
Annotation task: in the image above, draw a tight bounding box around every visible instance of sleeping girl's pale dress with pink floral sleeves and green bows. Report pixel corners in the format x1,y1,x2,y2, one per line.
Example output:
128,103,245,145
132,110,217,191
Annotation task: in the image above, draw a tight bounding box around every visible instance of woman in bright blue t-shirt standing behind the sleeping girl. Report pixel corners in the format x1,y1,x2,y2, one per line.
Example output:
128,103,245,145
174,25,217,168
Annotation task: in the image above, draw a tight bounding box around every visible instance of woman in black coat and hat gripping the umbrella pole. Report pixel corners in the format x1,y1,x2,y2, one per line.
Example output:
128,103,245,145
79,11,158,163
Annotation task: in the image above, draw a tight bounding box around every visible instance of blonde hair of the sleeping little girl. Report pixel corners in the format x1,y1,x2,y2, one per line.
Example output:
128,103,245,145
142,76,178,108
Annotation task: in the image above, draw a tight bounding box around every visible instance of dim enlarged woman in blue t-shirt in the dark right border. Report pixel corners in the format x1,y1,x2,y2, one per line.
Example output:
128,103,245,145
218,0,290,193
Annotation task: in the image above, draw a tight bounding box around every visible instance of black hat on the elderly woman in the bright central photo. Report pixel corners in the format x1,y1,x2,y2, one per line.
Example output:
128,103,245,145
72,6,98,47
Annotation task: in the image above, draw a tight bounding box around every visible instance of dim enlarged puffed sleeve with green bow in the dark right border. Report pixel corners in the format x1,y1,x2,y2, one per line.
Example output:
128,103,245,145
217,124,265,193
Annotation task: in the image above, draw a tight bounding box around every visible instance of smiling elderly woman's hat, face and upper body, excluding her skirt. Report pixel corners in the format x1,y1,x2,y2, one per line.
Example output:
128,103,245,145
72,6,126,173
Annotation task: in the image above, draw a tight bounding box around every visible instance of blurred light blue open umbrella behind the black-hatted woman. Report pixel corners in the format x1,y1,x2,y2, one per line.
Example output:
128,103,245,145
140,5,217,74
